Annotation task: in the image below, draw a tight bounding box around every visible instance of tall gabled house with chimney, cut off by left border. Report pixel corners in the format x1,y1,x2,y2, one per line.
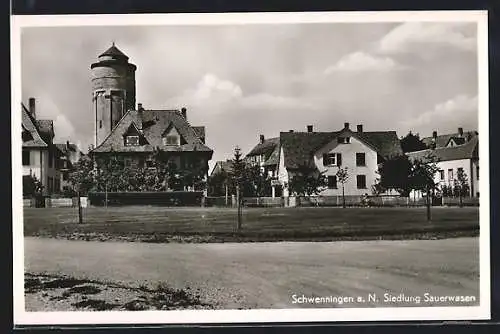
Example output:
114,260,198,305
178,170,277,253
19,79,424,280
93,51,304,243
21,98,62,195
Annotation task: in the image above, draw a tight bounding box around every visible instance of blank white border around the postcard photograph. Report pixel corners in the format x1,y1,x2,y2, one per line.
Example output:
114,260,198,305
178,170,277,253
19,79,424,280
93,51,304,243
11,11,491,325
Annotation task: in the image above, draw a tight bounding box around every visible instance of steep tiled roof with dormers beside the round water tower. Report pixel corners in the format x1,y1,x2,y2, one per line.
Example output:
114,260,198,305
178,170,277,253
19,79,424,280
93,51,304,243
92,110,213,153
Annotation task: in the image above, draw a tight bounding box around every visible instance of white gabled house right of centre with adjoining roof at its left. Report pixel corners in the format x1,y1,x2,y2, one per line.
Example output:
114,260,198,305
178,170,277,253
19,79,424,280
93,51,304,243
246,123,403,197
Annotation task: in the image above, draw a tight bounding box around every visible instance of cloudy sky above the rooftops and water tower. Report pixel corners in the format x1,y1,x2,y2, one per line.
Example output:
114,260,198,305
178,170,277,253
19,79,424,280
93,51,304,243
21,22,478,170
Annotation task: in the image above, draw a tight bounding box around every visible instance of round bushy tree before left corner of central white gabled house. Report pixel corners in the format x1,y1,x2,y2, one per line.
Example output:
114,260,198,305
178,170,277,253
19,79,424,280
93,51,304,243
289,162,327,196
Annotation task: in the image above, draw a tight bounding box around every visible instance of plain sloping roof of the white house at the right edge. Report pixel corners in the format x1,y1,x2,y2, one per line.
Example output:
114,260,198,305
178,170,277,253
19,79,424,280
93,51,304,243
407,135,479,161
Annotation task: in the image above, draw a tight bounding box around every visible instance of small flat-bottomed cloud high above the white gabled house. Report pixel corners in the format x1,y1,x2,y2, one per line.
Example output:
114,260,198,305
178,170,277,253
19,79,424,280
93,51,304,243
325,51,403,74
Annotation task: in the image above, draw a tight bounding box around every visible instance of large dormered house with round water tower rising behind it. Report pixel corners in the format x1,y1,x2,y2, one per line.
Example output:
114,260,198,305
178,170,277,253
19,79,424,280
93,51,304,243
89,44,213,190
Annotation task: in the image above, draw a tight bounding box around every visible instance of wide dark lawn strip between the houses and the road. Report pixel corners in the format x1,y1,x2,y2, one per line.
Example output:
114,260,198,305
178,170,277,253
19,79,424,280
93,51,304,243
24,206,479,242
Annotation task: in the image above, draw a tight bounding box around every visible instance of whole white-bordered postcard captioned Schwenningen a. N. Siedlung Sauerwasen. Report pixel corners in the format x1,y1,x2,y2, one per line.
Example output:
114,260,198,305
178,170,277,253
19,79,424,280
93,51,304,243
11,11,490,324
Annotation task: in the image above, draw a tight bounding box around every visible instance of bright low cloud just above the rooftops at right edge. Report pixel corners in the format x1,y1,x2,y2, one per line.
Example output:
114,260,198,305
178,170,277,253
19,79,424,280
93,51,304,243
404,94,478,132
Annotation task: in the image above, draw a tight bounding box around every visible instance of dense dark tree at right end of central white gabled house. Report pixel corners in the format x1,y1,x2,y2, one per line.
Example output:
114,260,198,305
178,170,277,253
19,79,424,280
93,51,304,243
377,154,412,196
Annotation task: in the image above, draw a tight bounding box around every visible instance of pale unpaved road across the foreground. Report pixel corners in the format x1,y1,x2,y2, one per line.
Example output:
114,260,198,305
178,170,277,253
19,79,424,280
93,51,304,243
24,237,479,308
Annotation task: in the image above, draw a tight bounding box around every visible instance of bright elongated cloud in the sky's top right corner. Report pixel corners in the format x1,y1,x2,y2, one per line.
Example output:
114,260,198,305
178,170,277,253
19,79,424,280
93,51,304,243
379,22,477,54
